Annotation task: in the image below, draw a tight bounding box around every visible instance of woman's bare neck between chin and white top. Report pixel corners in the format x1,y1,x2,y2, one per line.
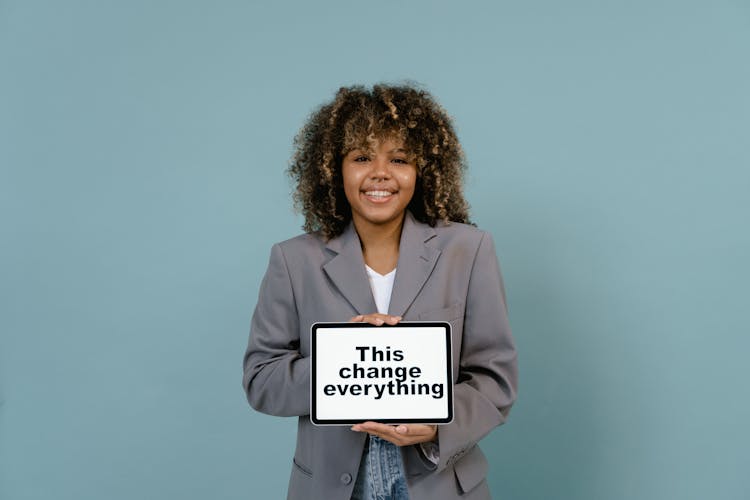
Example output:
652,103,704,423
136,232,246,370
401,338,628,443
353,212,404,274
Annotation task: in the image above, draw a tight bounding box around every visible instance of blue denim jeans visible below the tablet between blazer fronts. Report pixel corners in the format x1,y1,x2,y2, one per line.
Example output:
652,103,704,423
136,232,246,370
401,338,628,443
352,436,409,500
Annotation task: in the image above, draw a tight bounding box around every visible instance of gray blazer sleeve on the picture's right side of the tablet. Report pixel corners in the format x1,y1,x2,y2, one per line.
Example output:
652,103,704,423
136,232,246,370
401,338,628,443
433,233,518,471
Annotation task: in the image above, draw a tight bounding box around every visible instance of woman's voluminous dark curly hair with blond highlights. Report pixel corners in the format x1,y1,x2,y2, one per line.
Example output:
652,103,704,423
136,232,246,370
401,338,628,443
287,84,471,239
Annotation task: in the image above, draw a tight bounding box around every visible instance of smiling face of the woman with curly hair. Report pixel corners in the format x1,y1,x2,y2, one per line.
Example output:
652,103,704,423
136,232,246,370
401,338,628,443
341,139,417,229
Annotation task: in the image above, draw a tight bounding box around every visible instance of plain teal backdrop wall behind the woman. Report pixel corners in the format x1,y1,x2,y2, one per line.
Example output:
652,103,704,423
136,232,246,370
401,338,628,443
0,0,750,500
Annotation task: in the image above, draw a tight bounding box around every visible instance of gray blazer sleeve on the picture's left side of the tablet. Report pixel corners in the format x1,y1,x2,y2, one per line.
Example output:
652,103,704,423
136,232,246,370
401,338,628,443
242,244,310,416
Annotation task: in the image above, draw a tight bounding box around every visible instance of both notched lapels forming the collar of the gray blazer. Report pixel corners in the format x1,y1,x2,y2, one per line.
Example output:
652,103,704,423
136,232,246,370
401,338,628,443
323,210,440,316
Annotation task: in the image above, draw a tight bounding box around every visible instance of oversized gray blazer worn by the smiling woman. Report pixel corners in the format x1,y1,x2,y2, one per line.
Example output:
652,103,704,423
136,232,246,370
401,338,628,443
243,212,518,500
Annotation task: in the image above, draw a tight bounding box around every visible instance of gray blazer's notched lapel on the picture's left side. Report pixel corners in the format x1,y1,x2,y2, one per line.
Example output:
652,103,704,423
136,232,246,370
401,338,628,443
323,223,378,314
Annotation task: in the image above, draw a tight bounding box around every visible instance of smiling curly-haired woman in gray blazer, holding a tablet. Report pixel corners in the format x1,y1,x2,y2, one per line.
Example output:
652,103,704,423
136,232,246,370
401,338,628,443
243,85,517,500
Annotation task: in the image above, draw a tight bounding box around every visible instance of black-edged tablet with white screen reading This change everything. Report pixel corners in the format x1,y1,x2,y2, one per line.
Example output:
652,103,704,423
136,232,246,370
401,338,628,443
310,322,453,425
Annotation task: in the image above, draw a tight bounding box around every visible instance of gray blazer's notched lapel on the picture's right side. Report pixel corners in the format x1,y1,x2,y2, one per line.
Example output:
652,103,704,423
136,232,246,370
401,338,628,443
388,211,440,316
